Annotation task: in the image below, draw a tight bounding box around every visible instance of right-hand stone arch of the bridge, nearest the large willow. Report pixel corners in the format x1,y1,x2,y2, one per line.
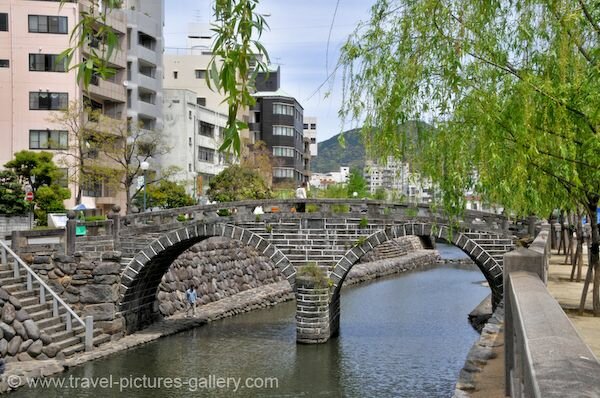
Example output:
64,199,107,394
330,222,503,308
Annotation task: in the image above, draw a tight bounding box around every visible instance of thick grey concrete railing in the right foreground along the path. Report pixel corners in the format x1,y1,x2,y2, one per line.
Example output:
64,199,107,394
504,225,600,397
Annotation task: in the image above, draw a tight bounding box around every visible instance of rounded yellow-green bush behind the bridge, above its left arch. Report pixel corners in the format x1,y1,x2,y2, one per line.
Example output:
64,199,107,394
207,165,271,202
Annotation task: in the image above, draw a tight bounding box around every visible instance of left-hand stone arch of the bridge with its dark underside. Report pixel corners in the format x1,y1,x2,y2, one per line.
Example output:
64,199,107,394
119,222,296,333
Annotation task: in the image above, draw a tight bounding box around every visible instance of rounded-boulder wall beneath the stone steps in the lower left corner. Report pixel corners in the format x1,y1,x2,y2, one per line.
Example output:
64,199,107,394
0,288,51,362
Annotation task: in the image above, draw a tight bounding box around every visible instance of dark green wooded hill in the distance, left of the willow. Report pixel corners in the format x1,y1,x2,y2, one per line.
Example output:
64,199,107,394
311,129,365,173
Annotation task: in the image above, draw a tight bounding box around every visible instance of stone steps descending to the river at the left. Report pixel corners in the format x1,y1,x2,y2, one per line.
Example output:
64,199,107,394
0,255,110,357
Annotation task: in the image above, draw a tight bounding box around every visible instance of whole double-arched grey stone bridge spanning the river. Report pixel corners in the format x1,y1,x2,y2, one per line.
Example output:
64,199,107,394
113,199,513,343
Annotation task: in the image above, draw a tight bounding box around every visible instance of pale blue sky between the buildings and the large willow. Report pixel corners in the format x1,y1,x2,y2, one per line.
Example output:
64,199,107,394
164,0,375,142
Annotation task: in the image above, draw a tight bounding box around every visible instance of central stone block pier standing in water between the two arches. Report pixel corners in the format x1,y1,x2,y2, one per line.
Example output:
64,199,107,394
296,275,340,344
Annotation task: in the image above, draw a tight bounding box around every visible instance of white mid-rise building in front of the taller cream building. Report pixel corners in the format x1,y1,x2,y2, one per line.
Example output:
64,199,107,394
161,88,230,201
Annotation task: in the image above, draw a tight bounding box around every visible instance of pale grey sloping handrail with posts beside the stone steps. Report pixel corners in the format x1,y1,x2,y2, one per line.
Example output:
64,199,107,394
0,241,94,351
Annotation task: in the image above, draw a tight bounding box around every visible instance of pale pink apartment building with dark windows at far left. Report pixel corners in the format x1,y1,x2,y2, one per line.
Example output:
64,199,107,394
0,0,127,211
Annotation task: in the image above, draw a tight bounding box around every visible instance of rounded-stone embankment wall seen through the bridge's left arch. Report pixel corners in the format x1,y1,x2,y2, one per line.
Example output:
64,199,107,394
158,237,283,316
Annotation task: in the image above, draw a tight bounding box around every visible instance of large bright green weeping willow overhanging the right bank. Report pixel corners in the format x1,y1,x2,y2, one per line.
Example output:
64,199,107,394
340,0,600,315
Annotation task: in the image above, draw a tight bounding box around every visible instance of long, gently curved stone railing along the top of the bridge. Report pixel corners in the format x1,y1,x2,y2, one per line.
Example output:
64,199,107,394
120,199,510,234
